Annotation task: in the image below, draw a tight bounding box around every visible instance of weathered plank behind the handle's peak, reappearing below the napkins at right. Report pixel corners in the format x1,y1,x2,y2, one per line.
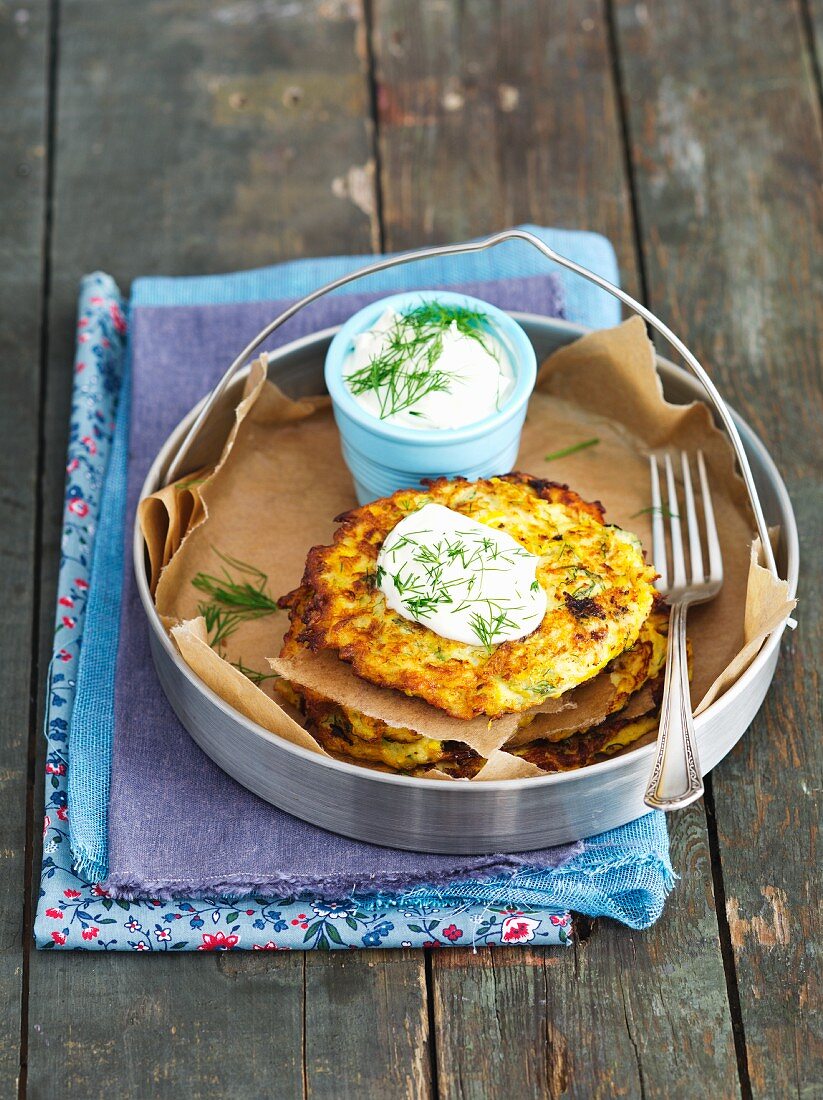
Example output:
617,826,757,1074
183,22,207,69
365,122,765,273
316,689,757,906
374,0,737,1098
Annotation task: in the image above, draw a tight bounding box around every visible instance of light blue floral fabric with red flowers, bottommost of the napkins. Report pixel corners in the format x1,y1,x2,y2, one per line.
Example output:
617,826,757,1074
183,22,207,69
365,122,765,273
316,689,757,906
34,274,571,952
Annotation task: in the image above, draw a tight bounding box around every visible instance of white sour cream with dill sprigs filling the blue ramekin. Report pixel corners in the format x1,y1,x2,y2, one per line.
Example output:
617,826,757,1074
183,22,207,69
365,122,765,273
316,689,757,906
343,303,514,430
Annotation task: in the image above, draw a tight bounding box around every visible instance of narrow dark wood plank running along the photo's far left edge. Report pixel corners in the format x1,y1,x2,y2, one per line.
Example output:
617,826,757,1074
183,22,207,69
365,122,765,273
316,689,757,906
0,0,50,1096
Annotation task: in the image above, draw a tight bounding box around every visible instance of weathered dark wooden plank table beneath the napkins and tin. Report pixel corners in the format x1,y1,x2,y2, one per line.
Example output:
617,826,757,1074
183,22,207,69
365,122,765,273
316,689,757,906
0,0,823,1100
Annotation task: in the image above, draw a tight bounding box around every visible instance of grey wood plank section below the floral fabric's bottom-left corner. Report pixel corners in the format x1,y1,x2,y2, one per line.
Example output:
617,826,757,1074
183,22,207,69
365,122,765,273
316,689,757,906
28,952,304,1100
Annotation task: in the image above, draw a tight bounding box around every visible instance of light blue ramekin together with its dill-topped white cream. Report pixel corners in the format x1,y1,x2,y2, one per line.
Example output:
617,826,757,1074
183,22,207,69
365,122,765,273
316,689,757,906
325,290,537,504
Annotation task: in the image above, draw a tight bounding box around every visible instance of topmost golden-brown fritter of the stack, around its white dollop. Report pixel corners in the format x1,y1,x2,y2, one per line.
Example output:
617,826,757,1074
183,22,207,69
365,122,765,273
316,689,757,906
281,473,655,718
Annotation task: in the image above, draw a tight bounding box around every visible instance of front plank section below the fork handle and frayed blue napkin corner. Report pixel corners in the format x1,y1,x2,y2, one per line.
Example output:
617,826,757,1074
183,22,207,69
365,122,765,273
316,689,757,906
435,806,737,1100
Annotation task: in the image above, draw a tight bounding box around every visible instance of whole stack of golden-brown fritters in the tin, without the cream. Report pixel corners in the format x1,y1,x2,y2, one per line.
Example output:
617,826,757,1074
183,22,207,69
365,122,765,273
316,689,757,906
275,473,668,778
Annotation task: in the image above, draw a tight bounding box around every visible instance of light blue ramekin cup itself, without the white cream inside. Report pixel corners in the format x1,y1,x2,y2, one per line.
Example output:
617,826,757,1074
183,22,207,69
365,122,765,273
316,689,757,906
326,290,537,504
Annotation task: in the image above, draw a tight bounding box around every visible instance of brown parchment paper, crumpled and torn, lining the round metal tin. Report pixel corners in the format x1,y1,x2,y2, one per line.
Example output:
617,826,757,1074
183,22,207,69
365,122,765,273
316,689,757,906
140,318,794,781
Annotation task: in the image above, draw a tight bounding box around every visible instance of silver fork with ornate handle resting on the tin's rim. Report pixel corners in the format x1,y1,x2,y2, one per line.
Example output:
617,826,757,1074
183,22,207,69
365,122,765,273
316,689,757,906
646,451,723,810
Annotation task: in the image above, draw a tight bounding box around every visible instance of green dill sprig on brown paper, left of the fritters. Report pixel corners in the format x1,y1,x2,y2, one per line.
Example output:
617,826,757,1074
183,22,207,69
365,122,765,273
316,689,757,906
191,547,277,648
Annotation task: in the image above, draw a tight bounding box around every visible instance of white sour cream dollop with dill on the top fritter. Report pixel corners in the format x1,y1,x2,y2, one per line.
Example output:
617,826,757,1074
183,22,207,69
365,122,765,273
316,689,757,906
376,504,547,650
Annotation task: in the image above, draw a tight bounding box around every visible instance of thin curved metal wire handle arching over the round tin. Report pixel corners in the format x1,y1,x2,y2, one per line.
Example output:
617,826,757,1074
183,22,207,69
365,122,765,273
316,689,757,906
165,229,778,576
